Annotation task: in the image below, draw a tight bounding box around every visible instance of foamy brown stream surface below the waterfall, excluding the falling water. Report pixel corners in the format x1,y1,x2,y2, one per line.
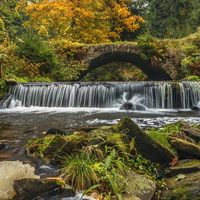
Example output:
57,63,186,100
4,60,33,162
0,107,200,170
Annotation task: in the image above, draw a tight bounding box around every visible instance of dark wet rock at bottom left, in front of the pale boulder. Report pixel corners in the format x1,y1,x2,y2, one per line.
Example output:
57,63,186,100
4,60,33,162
13,178,59,200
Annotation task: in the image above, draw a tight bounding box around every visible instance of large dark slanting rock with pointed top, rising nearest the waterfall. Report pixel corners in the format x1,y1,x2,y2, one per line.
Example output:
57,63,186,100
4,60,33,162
112,117,176,164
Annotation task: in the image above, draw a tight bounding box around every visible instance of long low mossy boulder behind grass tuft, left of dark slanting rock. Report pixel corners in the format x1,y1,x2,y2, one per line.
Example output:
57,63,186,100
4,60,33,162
26,126,134,164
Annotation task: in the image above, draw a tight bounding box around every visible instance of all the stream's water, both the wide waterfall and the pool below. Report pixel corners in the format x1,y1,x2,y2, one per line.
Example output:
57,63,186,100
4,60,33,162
0,82,200,197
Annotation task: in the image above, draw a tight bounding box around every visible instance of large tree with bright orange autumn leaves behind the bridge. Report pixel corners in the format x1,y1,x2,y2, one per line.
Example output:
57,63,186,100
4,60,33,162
18,0,144,43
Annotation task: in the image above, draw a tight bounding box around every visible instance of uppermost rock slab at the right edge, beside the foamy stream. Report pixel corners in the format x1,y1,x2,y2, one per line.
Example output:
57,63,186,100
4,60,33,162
180,122,200,143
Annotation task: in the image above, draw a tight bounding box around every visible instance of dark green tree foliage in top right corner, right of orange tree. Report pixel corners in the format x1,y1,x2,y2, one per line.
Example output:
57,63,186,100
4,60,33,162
145,0,200,38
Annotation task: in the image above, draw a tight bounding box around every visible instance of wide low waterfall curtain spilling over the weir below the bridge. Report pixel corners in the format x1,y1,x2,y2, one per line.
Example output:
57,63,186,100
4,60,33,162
1,81,200,109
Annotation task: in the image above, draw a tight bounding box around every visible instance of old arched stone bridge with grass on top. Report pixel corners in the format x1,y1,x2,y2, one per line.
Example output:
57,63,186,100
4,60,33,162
74,42,182,81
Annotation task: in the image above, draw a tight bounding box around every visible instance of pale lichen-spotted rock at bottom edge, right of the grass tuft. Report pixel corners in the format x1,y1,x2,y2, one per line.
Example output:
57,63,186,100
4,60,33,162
123,171,156,200
